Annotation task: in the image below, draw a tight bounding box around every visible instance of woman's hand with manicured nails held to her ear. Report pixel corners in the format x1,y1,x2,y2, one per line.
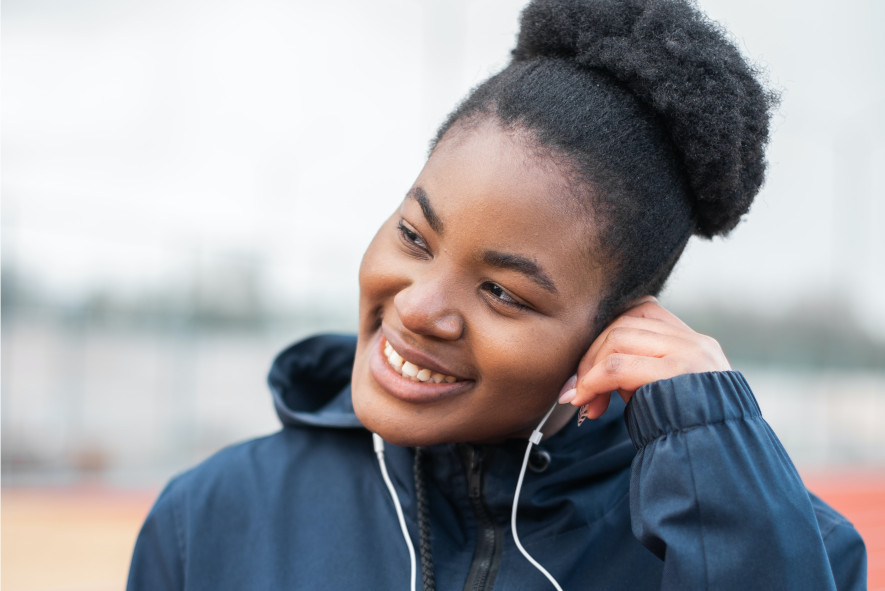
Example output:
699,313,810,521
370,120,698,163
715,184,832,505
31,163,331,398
559,296,731,419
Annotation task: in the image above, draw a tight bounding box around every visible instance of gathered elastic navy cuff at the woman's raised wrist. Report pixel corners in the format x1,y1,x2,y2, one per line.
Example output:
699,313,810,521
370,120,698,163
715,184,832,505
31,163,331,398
624,371,761,449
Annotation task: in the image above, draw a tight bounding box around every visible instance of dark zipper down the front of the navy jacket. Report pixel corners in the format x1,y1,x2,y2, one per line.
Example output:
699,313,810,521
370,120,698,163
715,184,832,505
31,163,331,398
460,444,502,591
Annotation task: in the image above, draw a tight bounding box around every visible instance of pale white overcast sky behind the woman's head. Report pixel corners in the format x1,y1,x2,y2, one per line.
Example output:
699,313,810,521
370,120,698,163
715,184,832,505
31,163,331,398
2,0,885,336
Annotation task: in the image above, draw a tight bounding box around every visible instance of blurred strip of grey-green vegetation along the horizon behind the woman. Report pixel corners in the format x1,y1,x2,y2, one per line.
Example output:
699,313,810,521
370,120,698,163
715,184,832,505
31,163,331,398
2,267,885,371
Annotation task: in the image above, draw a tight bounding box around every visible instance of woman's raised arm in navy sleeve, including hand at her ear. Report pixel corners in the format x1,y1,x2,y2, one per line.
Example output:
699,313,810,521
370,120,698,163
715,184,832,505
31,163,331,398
564,298,866,591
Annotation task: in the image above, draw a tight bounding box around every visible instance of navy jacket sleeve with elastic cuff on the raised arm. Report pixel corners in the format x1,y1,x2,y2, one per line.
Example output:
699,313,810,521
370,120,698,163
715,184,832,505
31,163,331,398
626,372,866,591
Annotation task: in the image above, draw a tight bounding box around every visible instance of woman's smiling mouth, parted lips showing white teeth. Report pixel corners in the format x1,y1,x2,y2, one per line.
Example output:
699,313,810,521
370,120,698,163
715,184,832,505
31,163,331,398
369,334,474,402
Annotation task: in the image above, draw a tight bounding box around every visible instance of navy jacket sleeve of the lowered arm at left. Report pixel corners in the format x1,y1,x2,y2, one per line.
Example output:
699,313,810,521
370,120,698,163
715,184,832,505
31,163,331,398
126,480,184,591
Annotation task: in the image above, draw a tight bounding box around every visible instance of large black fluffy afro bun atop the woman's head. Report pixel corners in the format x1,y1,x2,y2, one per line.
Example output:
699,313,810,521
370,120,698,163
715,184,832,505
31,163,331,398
513,0,776,238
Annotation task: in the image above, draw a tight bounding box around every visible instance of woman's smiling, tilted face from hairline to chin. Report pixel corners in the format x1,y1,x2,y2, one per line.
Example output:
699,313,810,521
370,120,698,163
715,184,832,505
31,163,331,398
353,121,600,445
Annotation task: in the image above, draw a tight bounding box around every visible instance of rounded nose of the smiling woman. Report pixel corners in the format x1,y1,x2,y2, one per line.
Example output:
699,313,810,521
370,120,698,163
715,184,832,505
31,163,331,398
393,277,464,341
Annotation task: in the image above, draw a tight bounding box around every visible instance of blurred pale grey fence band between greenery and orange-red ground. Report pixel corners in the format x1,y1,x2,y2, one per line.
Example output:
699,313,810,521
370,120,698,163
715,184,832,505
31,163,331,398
2,308,885,487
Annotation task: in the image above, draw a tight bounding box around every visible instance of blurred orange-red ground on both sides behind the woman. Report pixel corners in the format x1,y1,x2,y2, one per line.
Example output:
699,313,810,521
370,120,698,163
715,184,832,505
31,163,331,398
0,470,885,591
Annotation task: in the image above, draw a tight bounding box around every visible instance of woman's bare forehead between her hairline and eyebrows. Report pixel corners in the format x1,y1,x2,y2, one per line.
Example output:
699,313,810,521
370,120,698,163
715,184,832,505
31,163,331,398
407,122,596,294
